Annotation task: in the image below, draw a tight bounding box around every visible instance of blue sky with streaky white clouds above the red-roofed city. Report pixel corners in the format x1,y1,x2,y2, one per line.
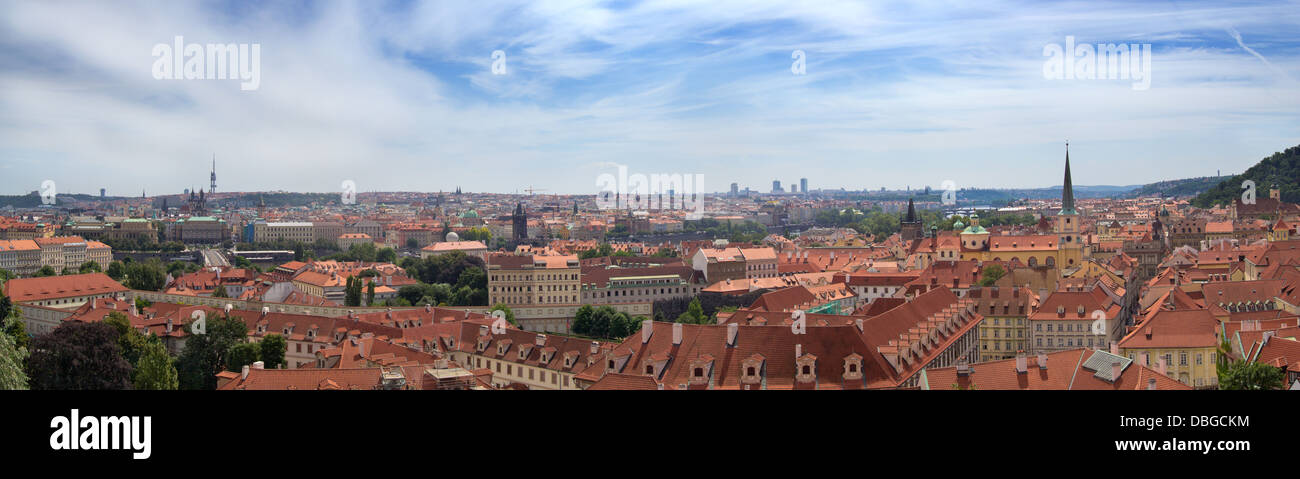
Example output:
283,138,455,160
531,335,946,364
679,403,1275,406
0,0,1300,195
